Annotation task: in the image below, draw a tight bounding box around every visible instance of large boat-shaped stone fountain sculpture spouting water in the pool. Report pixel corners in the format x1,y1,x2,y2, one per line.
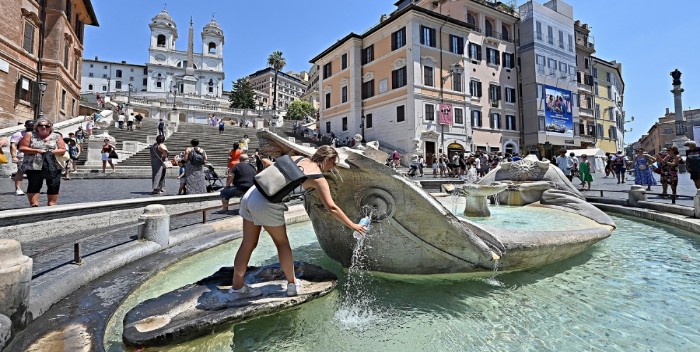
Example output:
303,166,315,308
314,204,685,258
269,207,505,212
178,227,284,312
257,130,615,274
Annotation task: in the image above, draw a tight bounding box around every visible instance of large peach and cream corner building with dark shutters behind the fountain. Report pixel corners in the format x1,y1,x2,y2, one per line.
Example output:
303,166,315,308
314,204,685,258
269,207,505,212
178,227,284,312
311,0,521,163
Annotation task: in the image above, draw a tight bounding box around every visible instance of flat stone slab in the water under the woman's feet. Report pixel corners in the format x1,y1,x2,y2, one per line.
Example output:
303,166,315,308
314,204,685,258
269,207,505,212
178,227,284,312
122,262,337,347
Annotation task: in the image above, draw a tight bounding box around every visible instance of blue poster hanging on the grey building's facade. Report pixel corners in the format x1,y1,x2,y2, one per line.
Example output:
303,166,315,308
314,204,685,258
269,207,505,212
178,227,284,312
543,85,574,137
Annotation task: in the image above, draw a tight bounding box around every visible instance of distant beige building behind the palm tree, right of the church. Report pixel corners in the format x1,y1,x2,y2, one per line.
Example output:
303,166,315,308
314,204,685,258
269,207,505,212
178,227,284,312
248,67,308,110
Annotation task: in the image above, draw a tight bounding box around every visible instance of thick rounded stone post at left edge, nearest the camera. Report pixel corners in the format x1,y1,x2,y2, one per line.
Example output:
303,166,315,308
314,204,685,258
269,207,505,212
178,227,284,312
0,238,33,334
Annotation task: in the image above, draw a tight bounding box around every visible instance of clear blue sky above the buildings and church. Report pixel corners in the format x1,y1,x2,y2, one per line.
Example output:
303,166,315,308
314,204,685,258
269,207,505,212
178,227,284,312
84,0,700,142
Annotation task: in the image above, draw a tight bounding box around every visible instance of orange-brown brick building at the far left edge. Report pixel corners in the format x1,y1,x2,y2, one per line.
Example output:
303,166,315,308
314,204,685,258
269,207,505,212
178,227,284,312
0,0,98,128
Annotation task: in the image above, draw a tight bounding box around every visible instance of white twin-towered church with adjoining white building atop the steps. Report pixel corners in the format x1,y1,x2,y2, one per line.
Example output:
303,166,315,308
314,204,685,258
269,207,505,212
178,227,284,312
81,10,225,98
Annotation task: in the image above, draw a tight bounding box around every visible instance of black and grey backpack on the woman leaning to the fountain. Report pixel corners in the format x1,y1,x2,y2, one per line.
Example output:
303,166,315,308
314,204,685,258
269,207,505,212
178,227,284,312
253,155,308,203
